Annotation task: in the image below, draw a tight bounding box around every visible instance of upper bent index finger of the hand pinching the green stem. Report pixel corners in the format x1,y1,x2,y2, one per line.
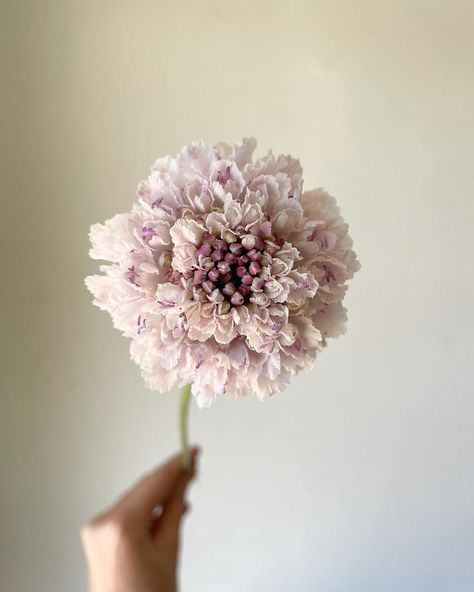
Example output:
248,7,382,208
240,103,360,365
111,448,198,526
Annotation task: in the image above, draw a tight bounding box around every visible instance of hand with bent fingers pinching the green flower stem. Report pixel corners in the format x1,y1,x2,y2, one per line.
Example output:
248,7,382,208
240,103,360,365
81,448,198,592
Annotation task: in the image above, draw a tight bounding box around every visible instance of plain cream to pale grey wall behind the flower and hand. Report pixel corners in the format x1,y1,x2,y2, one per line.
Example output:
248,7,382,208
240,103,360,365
0,0,474,592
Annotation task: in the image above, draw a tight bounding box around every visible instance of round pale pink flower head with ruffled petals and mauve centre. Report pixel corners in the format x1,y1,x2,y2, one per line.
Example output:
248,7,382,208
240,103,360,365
86,139,360,407
